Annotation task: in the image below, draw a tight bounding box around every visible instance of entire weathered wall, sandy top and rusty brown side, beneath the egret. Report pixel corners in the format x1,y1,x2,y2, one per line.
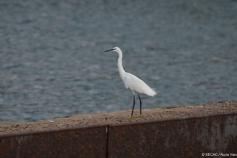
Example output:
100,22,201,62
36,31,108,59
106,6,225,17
0,102,237,158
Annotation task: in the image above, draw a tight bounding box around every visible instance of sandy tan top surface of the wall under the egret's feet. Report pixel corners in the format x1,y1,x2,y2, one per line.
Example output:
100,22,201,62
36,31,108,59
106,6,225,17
0,101,237,137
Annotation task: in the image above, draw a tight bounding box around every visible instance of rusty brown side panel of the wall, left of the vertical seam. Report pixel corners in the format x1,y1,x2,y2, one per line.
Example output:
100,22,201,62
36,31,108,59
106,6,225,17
0,126,106,158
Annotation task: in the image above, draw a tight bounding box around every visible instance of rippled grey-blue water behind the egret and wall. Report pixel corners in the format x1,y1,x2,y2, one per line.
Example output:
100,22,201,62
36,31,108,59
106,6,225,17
0,0,237,121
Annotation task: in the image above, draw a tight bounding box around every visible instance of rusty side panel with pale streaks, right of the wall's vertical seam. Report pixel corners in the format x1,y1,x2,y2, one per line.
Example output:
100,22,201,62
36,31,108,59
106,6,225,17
109,115,237,158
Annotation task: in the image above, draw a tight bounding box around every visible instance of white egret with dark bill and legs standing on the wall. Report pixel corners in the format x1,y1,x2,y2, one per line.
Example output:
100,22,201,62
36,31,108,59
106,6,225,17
105,47,156,117
